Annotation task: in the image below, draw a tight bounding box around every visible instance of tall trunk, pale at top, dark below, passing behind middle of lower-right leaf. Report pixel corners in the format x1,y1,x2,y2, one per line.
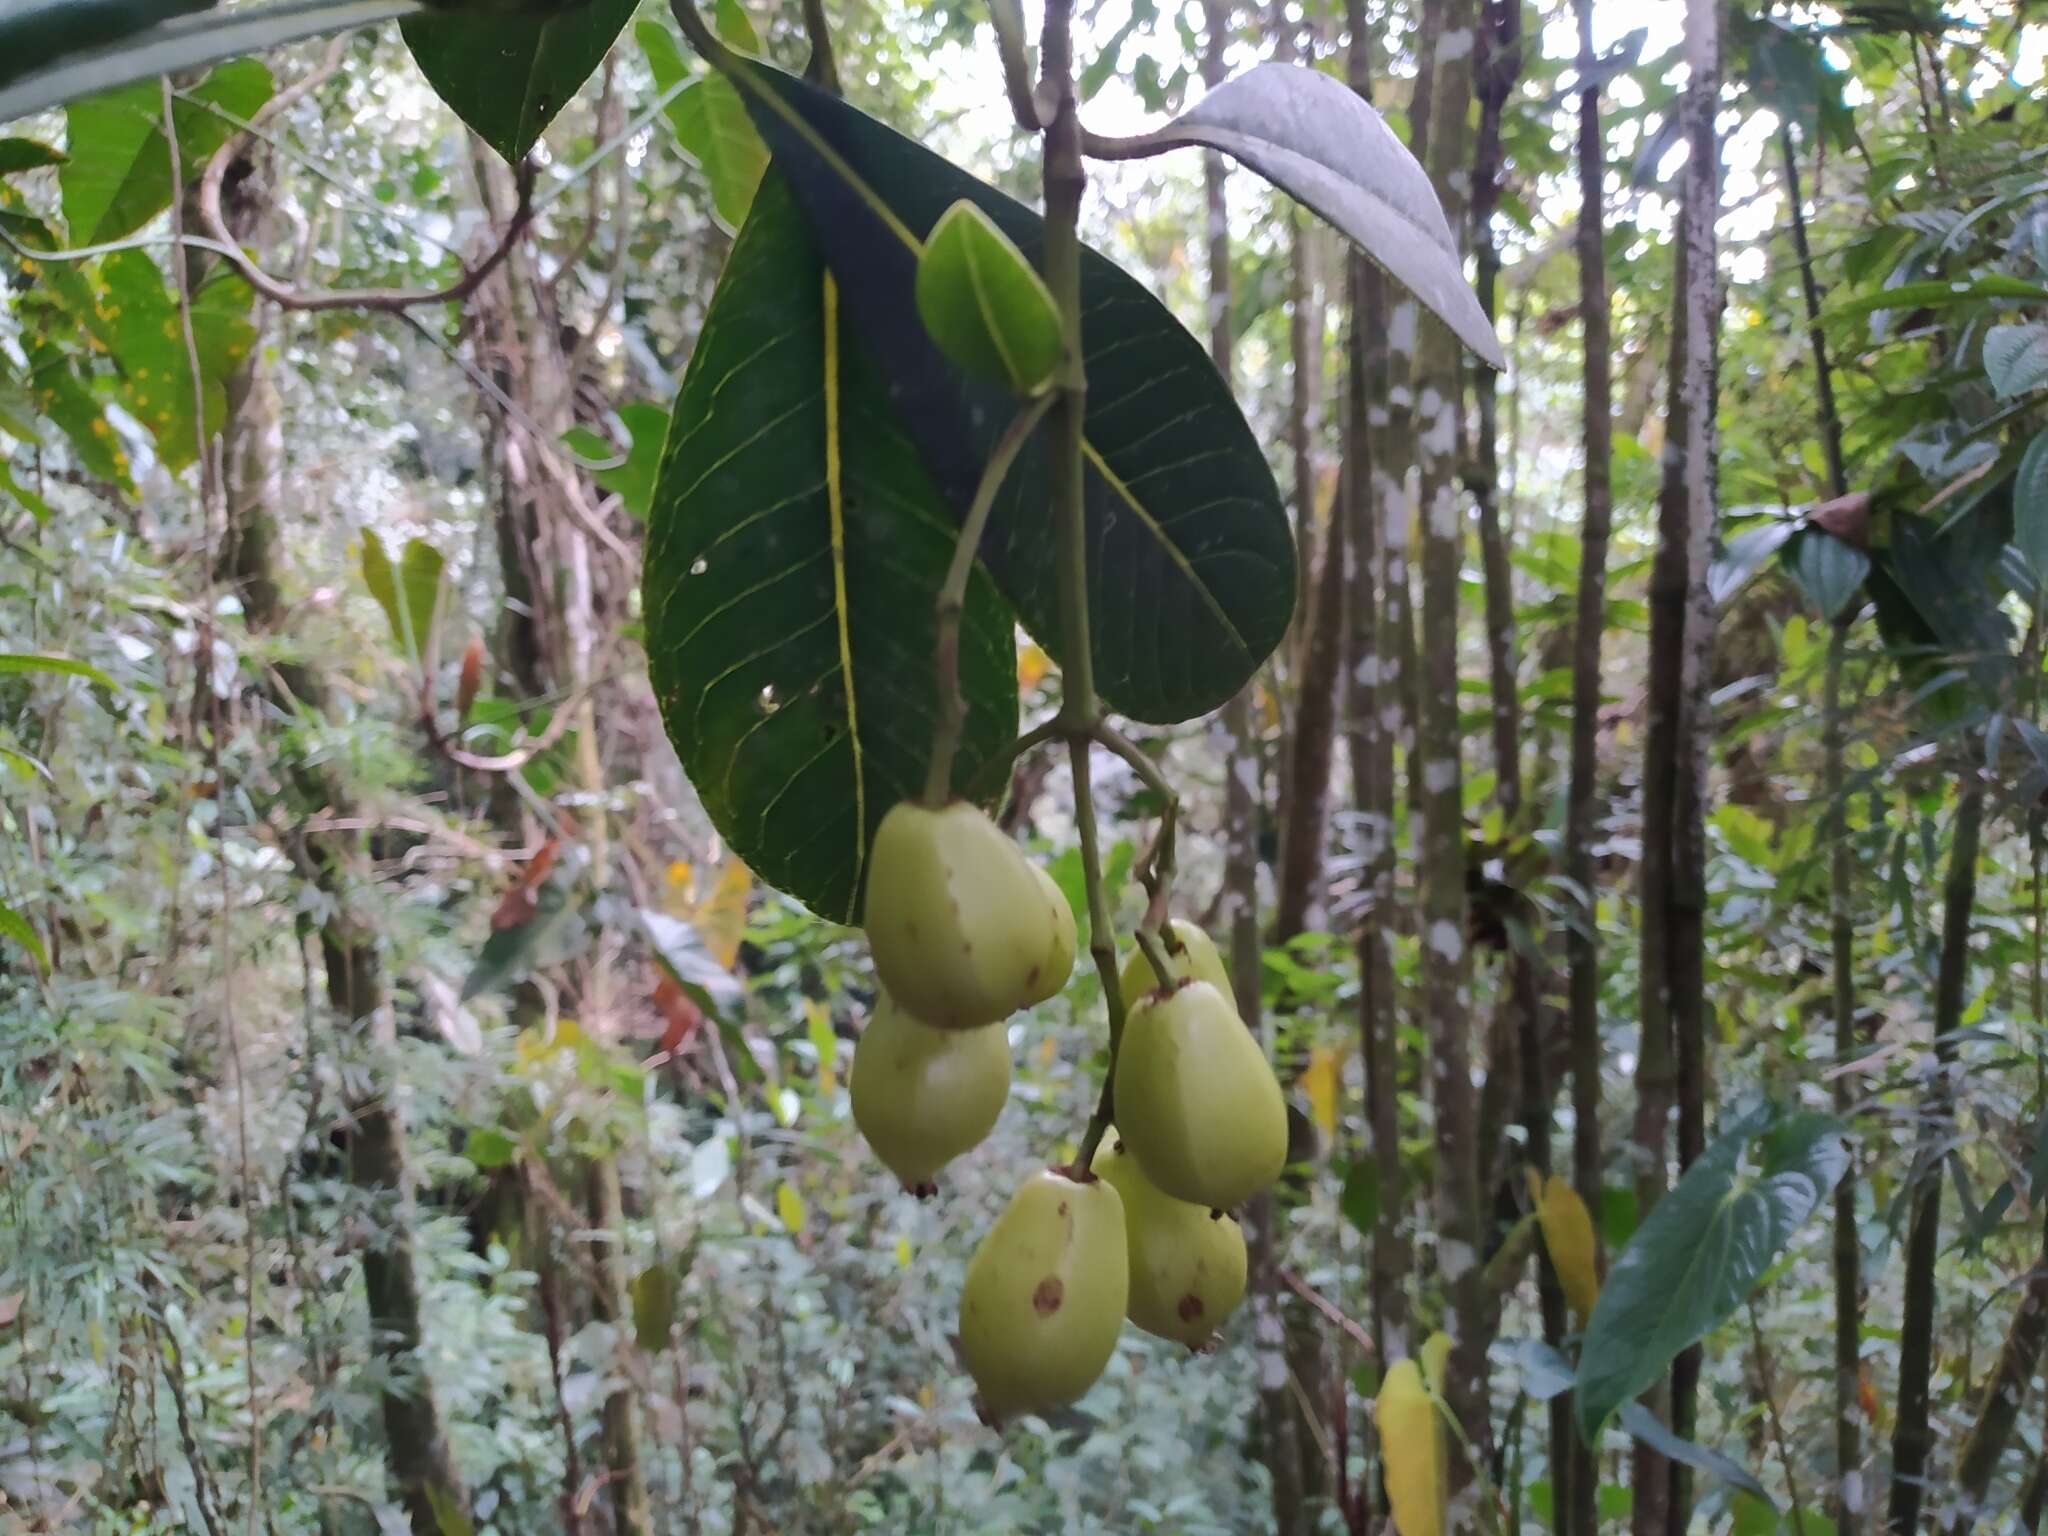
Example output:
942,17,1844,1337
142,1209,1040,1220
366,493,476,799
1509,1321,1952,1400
1665,0,1720,1536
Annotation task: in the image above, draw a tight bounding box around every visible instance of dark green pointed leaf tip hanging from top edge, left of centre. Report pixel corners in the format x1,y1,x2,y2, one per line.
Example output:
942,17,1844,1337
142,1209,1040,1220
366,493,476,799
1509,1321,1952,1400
399,0,635,164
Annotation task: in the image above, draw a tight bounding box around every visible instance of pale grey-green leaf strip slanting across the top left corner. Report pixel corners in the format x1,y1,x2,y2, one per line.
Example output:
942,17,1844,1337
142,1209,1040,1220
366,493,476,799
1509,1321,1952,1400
0,0,420,123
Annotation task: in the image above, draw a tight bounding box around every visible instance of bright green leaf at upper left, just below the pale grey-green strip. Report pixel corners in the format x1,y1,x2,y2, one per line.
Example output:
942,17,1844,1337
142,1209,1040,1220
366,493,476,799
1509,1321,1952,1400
57,59,270,246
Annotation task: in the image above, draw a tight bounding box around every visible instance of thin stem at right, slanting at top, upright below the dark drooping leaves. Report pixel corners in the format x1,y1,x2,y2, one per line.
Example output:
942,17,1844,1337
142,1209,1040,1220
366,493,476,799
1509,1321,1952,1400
1778,123,1864,1528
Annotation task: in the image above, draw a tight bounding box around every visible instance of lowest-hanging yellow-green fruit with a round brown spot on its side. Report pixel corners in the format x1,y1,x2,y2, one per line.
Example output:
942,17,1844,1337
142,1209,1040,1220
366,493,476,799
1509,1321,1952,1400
961,1169,1130,1421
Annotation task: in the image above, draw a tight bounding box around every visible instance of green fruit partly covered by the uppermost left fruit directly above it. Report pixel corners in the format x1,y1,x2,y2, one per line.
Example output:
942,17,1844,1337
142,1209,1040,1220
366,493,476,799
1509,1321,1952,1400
852,993,1010,1194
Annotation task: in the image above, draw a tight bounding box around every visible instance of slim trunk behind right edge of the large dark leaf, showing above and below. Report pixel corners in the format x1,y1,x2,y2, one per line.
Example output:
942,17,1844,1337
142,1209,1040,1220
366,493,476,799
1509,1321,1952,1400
1202,0,1309,1536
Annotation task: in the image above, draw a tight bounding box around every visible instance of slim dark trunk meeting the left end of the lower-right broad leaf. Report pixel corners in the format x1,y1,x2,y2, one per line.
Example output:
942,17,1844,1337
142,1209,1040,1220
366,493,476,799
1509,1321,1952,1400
1556,0,1614,1536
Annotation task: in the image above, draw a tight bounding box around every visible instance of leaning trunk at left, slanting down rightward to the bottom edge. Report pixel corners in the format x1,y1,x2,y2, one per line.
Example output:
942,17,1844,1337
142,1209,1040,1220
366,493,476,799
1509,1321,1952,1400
195,153,469,1536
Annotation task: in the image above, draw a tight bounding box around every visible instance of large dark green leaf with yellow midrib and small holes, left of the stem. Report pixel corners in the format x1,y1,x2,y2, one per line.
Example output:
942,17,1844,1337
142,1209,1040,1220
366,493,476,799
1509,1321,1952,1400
645,174,1018,925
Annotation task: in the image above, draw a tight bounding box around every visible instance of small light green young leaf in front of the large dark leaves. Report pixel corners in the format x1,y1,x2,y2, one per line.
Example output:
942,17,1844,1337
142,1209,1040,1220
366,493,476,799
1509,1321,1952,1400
918,199,1061,395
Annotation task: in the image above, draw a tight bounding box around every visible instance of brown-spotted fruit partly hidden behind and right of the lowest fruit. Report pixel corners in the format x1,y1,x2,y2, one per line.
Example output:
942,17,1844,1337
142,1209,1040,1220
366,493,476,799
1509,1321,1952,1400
1094,1126,1245,1350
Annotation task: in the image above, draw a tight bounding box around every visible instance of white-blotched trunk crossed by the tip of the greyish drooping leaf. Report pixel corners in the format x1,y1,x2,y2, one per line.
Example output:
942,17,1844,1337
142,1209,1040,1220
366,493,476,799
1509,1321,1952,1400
1409,0,1491,1532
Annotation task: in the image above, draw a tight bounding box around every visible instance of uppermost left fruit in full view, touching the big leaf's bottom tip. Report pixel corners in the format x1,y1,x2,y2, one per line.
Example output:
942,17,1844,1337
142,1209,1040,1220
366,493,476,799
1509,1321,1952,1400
866,801,1073,1030
